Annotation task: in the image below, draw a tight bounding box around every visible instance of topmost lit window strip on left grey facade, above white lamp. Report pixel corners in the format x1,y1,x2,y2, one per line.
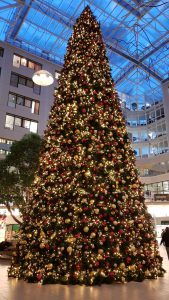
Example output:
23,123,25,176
13,54,42,71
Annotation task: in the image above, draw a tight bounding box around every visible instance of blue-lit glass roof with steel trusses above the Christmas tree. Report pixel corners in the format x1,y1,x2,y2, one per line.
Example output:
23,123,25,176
0,0,169,101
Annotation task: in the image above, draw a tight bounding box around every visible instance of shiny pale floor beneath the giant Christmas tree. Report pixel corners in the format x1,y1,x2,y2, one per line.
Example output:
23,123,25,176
0,246,169,300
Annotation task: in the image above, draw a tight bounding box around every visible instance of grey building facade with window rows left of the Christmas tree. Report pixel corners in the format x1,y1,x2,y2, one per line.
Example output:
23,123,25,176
0,43,61,157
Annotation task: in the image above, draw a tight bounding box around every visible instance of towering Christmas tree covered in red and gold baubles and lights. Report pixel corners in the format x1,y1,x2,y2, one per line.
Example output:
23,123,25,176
9,7,164,285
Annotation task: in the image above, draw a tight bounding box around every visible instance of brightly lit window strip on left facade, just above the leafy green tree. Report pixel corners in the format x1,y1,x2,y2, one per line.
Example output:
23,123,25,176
5,115,38,133
